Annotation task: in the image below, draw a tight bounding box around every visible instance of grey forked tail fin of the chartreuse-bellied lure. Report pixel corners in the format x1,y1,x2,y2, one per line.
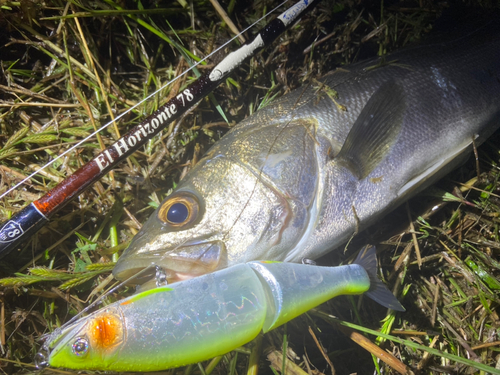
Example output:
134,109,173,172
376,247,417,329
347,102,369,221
353,246,406,311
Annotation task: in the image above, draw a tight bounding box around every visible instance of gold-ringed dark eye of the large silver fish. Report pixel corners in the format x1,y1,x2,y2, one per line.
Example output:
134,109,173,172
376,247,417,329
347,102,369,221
158,191,200,229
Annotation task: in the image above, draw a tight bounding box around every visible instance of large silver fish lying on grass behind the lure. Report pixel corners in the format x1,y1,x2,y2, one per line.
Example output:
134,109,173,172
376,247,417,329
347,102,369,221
113,24,500,284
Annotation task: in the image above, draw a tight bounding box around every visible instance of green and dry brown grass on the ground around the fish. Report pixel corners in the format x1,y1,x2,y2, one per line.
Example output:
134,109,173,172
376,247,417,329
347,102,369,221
0,0,500,374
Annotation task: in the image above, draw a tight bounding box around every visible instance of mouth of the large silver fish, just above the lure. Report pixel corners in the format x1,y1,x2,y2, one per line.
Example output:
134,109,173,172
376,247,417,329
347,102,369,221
113,241,227,291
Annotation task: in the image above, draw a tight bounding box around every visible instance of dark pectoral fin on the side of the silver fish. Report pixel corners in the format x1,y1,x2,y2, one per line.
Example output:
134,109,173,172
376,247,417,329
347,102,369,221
335,81,406,179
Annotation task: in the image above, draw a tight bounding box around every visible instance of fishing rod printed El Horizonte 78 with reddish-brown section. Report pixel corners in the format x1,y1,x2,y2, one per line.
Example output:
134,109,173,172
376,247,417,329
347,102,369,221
0,0,315,259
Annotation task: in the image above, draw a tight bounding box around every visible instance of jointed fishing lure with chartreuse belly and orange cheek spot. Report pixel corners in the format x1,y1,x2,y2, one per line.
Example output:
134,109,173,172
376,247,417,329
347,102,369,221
37,247,404,371
